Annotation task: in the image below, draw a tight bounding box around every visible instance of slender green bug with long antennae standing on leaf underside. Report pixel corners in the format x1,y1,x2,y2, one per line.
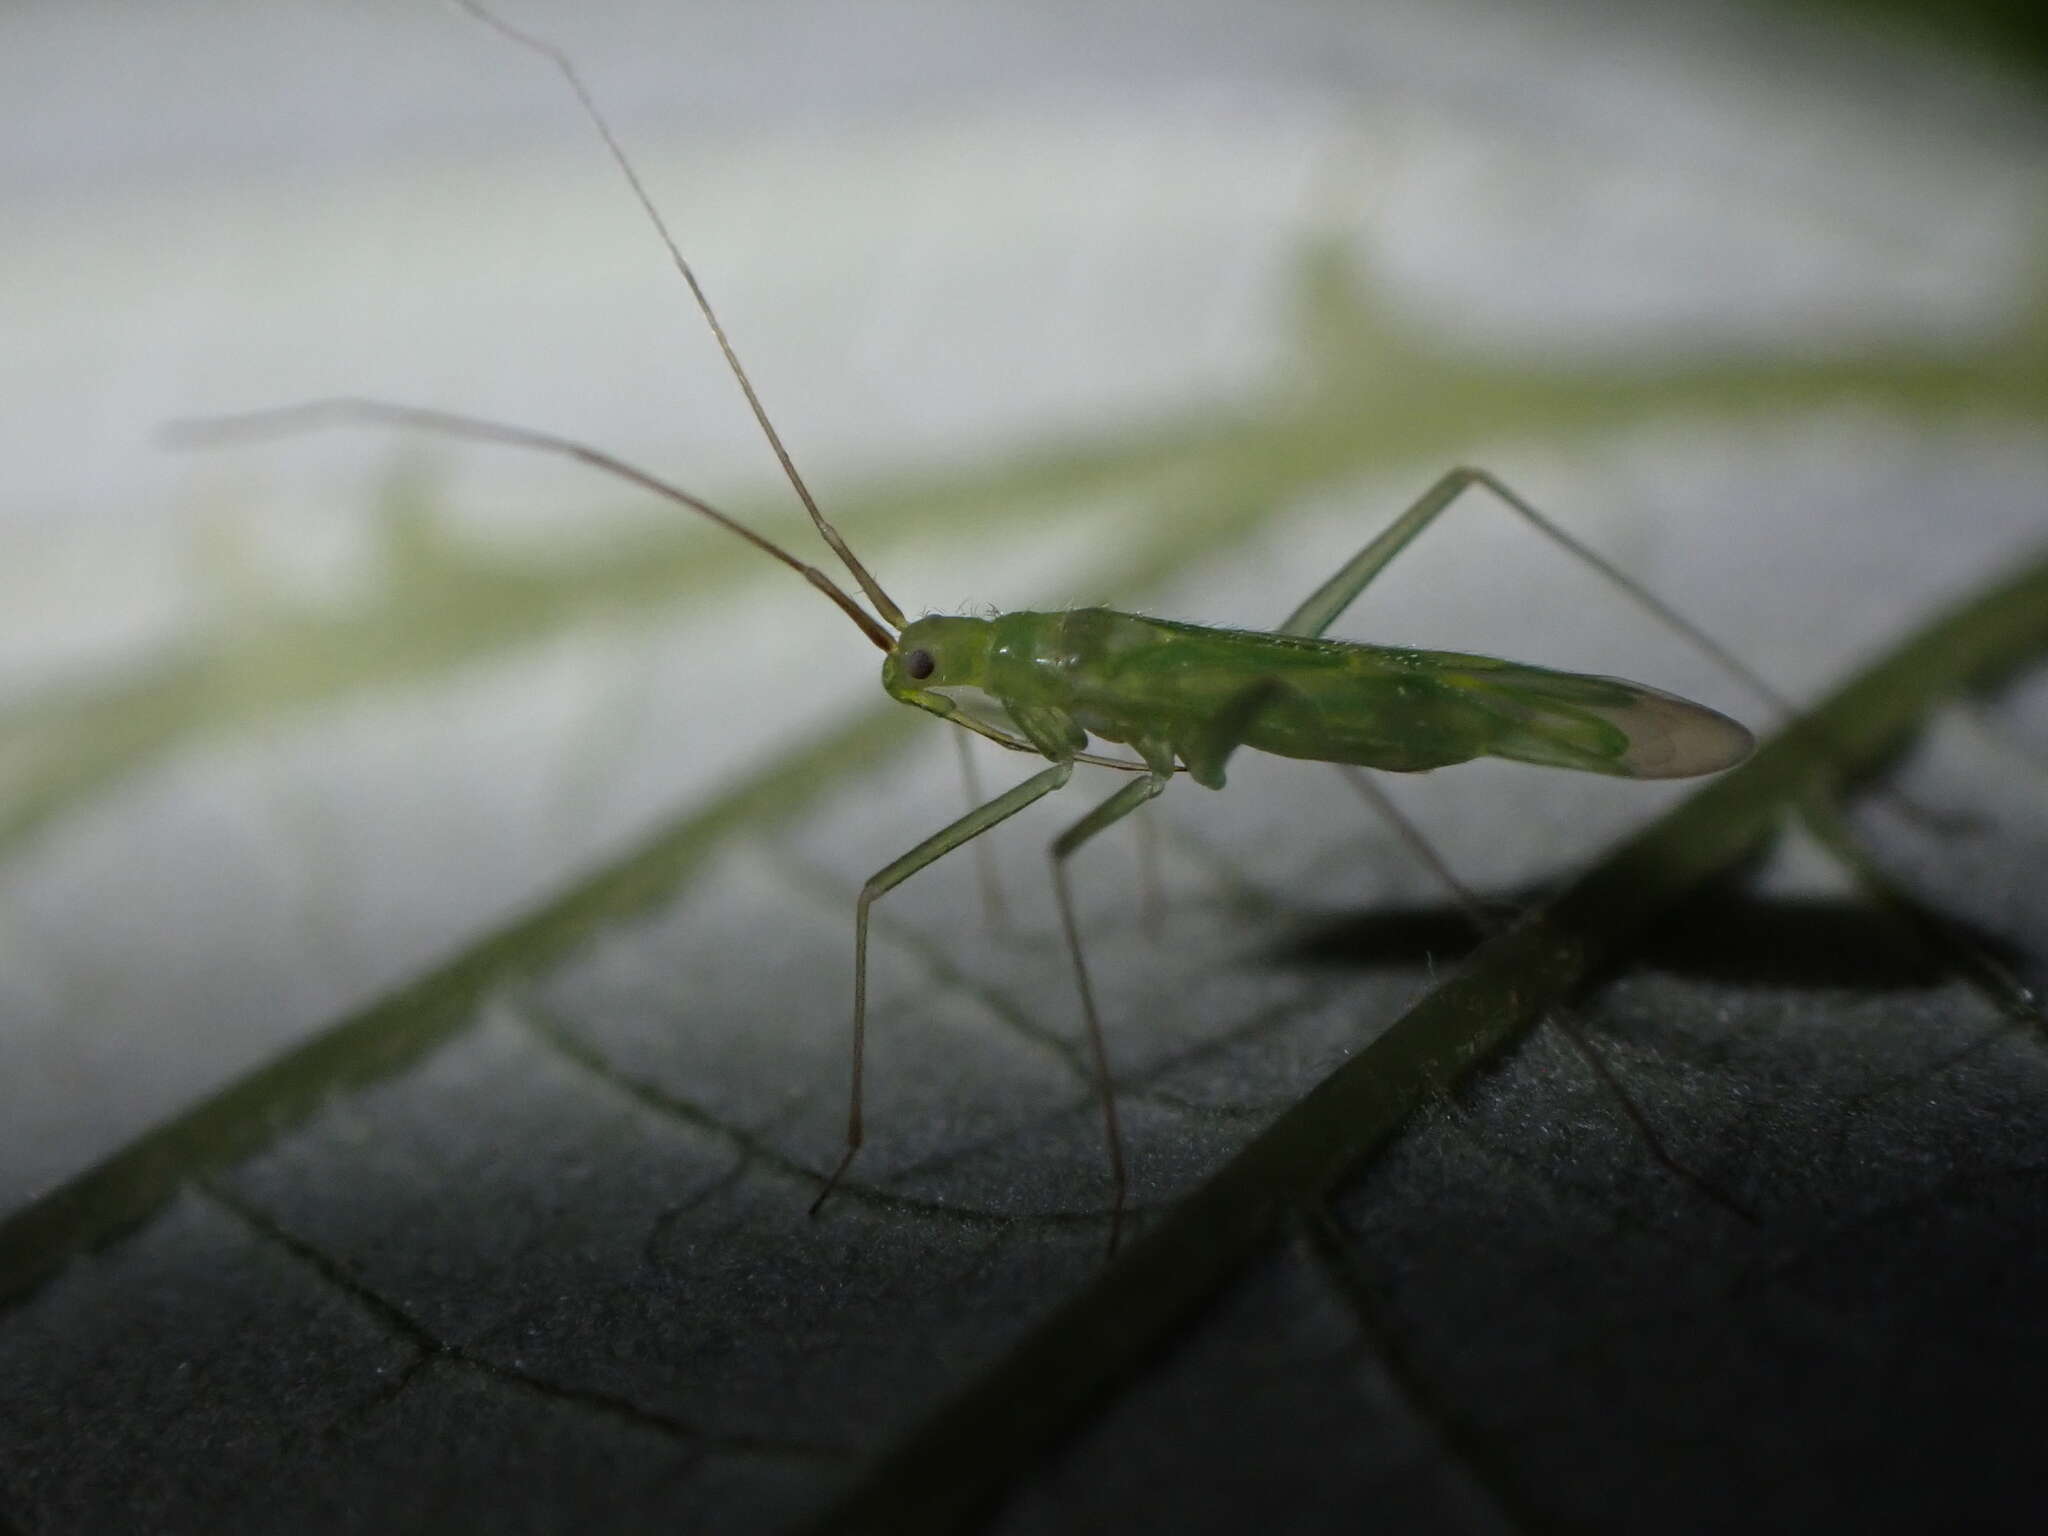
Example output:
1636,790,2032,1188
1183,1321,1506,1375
170,0,1769,1249
